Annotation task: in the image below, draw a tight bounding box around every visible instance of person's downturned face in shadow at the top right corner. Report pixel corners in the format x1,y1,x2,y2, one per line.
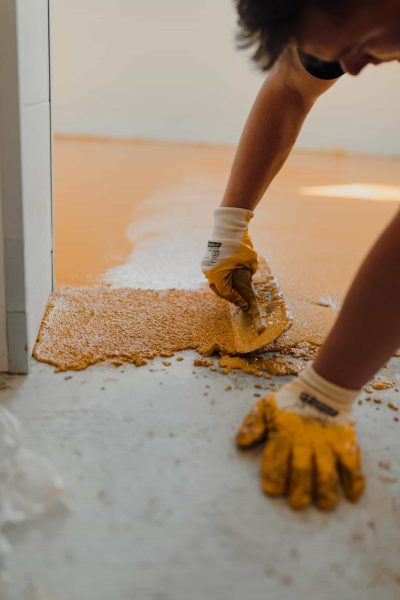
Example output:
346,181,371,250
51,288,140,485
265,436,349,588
296,0,400,75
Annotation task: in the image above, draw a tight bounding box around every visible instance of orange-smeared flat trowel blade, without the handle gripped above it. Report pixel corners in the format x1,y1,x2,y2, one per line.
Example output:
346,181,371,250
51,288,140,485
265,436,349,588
230,260,292,354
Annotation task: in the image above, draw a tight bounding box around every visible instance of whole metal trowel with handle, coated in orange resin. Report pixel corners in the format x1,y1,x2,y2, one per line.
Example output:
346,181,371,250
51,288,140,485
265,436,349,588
230,261,292,354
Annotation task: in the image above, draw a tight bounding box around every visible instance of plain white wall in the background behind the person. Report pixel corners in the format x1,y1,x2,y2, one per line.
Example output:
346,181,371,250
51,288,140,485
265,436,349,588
50,0,400,154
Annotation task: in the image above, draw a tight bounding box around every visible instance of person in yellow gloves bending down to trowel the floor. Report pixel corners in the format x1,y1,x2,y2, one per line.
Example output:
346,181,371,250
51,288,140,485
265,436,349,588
202,0,400,509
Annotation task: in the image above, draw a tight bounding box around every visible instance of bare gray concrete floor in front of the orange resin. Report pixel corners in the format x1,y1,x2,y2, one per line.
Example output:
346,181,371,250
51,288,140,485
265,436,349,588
0,352,400,600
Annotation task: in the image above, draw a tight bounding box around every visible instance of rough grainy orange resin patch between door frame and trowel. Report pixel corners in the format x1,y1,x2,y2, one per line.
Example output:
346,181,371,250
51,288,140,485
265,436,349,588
34,287,289,371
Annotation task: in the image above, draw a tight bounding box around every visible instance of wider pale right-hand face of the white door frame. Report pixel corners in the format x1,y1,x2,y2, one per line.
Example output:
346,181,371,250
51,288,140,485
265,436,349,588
17,0,53,356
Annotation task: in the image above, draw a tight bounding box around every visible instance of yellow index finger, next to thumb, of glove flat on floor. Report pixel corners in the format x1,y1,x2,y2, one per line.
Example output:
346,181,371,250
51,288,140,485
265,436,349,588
261,433,290,496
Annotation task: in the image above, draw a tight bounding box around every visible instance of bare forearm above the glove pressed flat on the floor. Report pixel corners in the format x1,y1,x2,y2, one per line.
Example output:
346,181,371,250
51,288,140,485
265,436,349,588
314,211,400,389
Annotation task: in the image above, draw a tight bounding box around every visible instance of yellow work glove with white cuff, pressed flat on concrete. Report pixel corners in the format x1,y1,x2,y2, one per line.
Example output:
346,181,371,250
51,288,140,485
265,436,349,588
236,367,365,510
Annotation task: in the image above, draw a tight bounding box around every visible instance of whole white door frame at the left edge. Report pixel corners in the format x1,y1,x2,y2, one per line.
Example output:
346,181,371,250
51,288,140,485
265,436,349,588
0,0,53,373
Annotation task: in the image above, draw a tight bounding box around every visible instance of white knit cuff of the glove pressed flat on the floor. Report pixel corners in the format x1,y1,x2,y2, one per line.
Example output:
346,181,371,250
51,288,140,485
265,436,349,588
277,365,360,425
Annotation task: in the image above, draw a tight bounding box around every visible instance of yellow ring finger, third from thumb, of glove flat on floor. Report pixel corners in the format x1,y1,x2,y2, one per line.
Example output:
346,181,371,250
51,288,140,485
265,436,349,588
314,444,339,510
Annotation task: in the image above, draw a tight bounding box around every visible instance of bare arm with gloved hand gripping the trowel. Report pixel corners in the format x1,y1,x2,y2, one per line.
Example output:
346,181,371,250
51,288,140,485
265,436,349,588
202,48,335,307
